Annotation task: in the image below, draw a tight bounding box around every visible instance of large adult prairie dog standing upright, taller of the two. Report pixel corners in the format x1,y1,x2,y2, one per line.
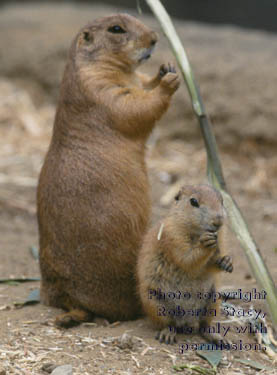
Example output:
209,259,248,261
37,14,179,326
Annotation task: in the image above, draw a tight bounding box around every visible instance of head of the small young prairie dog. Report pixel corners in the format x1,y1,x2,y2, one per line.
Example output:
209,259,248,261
171,185,224,235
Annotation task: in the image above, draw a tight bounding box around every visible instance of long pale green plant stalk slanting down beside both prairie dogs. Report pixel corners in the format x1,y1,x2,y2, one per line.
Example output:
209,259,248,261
145,0,277,329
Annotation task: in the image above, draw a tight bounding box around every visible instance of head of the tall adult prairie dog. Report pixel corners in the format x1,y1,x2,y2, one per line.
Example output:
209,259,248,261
73,14,158,68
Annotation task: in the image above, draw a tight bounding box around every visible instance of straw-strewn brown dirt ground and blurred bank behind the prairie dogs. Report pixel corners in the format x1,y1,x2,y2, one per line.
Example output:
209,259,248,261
0,5,277,375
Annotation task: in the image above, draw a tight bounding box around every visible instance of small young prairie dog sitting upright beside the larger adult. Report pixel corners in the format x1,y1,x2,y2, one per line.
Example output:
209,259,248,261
137,185,233,344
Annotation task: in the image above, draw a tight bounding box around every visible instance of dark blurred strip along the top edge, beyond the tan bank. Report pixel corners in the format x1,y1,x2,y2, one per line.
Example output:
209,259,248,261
0,0,277,32
